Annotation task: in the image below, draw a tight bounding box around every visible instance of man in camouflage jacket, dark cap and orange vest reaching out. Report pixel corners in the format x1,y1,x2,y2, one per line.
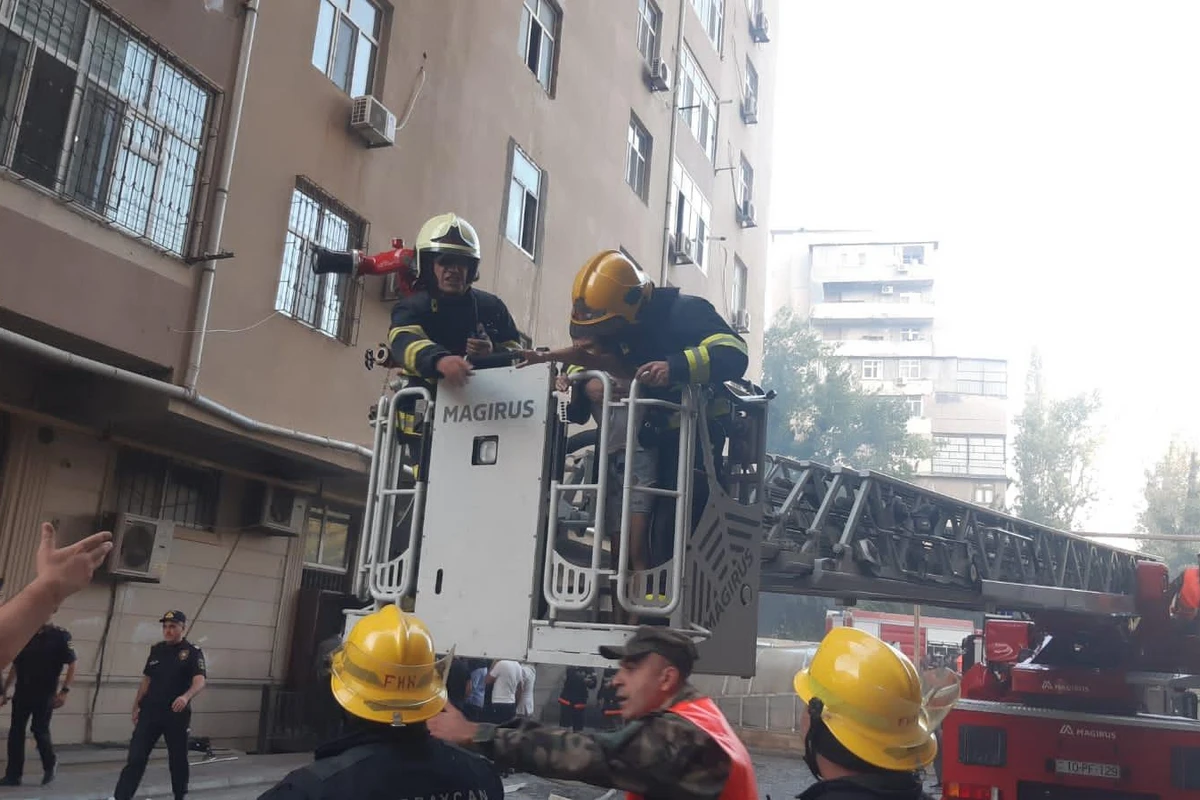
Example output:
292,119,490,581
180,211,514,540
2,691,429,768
428,626,757,800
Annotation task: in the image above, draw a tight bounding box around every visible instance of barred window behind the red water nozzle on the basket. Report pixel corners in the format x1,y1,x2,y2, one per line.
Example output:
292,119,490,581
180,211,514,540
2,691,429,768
275,179,367,345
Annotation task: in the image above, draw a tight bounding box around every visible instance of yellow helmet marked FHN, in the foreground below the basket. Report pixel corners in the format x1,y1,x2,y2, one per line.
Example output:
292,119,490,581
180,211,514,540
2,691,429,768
330,604,454,726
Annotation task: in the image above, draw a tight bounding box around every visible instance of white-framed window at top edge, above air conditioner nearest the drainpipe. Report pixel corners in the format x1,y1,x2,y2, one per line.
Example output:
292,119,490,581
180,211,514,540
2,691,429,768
312,0,384,97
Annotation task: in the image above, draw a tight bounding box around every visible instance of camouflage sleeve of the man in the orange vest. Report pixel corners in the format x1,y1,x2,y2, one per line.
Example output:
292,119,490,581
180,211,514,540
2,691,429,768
475,714,731,800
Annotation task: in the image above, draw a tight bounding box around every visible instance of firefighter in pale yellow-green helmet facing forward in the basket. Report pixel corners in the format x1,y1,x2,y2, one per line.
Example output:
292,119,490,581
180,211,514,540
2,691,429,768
388,213,521,386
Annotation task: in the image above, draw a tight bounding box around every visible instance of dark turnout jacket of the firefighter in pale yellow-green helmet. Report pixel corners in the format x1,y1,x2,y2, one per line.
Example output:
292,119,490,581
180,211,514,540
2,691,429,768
388,289,521,380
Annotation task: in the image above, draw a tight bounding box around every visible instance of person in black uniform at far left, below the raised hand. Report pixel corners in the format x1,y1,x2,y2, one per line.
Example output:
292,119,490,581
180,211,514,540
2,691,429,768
0,624,76,786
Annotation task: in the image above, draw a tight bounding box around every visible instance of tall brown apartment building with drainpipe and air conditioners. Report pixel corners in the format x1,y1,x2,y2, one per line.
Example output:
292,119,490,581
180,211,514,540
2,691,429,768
0,0,776,746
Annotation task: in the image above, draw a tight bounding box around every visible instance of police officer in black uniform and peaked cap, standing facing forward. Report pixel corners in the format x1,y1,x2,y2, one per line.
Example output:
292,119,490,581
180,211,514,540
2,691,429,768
113,610,205,800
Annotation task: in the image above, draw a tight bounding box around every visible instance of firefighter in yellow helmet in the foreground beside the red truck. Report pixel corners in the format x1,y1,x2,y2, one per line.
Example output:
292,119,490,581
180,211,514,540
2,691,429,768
794,627,959,800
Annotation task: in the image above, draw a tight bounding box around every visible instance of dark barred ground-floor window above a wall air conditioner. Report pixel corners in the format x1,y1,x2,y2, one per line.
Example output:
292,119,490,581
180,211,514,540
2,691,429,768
116,450,221,530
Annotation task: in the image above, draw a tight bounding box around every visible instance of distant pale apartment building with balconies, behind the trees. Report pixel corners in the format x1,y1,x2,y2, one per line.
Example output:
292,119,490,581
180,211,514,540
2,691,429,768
766,230,1008,505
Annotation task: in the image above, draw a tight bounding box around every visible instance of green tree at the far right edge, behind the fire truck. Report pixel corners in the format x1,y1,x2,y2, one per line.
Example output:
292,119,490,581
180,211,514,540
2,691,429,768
1138,441,1200,576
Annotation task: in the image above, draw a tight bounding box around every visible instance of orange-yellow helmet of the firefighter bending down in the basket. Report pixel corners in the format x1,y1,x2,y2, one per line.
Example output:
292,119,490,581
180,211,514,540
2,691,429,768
571,249,654,338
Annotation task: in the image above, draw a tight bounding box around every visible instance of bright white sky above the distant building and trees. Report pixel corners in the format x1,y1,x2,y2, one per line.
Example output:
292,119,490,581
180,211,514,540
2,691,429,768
770,0,1200,531
